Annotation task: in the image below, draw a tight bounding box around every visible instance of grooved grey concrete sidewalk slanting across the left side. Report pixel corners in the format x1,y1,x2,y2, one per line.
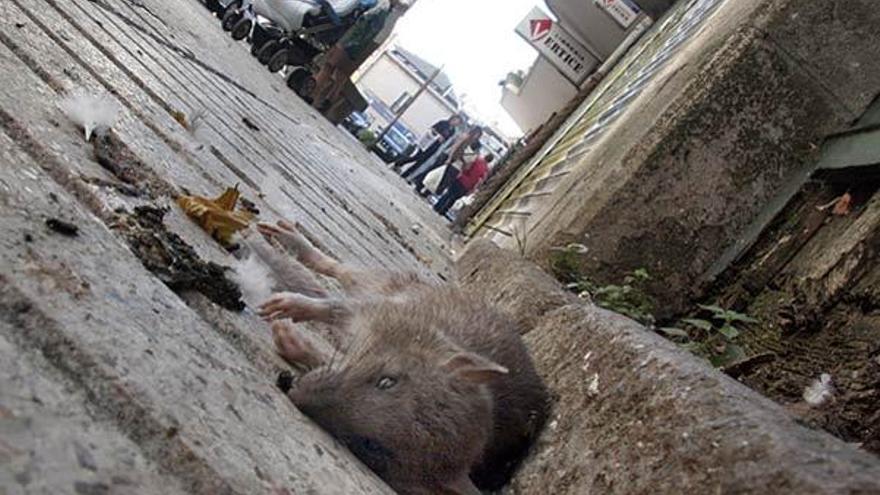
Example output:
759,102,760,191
0,0,451,495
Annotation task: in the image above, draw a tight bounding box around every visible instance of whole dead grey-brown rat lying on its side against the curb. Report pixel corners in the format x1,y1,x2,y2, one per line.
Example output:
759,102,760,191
259,222,548,495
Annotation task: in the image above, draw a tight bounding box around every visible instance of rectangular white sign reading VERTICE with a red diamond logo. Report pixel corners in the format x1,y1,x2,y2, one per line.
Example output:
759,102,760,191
516,7,595,87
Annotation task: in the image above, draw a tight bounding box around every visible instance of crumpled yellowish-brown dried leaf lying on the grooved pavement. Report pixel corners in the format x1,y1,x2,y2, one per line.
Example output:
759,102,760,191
177,186,254,245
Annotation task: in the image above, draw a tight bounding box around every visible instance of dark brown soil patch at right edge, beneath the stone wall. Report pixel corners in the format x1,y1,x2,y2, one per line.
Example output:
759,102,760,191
703,172,880,454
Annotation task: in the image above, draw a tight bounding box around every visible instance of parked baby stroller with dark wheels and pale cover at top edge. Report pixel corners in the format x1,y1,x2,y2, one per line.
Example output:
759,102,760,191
223,0,380,72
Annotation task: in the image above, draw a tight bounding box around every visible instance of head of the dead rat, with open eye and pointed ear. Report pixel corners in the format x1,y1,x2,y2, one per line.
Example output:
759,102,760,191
290,303,507,487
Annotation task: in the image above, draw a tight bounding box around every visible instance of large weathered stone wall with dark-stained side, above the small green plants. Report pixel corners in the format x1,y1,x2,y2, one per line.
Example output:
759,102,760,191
488,0,880,316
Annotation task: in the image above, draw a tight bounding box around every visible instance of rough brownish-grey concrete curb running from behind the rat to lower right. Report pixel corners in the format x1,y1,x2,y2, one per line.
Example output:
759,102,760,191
458,242,880,494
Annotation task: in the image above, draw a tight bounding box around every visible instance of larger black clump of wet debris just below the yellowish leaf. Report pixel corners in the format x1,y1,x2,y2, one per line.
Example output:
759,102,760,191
113,206,245,311
